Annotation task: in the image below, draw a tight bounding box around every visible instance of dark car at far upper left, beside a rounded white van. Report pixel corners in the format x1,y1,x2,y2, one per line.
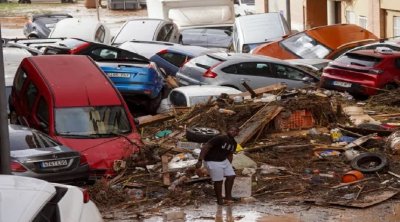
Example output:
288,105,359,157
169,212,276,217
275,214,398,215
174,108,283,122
23,14,72,39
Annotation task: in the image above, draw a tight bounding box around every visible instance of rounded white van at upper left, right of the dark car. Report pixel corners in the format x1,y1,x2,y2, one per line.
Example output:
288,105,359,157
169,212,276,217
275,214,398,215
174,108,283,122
49,18,111,45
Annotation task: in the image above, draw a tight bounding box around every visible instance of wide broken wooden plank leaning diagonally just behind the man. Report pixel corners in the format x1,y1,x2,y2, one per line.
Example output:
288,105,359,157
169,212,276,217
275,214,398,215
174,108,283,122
235,105,283,145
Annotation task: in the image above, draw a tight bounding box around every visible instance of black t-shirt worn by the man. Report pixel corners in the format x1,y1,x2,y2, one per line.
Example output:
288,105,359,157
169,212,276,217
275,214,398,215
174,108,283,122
204,135,237,162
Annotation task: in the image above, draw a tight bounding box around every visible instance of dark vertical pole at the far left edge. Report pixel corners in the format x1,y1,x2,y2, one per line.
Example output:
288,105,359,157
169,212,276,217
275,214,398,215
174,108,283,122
0,24,11,174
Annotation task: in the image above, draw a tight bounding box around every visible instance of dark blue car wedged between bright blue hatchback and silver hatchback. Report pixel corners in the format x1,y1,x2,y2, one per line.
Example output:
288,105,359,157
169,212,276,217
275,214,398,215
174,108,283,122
150,45,215,76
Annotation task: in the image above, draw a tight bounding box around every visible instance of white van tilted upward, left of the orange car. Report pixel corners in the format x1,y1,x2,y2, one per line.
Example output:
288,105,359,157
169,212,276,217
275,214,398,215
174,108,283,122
232,12,290,53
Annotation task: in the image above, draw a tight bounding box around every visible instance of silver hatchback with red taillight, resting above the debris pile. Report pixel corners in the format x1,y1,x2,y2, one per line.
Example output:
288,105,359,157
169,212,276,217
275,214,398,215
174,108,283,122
176,53,319,91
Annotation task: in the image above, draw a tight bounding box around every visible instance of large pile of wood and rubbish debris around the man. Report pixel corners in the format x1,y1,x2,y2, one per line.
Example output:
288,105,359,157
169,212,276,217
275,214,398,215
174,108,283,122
88,84,400,219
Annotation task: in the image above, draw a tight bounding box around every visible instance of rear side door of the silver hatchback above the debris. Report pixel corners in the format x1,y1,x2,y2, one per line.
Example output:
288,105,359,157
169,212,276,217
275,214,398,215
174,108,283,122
222,62,278,91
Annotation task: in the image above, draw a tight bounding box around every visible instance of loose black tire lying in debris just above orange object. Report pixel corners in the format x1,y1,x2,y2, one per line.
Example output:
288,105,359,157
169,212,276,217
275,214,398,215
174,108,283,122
351,153,388,173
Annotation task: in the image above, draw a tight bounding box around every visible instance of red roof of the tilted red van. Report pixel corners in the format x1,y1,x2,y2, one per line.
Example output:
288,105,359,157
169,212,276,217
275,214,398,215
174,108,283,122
27,55,121,107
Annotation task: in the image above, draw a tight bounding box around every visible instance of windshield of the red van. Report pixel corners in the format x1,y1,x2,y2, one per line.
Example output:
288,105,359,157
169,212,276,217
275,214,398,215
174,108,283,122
55,106,131,137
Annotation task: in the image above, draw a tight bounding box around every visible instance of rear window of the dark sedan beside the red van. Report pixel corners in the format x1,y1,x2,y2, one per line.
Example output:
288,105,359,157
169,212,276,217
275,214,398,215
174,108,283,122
10,130,59,151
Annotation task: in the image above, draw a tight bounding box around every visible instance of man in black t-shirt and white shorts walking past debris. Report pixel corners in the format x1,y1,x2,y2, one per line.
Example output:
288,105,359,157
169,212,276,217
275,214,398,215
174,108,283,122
196,126,239,205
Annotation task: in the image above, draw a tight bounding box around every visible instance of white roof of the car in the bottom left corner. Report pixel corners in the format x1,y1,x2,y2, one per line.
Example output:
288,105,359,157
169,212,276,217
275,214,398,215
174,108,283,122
0,175,56,221
